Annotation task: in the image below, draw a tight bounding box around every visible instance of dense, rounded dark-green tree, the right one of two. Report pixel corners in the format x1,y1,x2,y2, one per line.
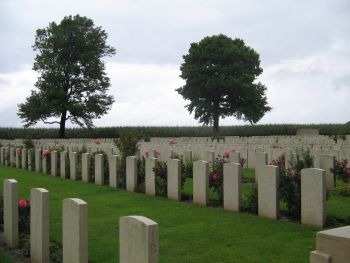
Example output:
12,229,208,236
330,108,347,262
176,34,271,134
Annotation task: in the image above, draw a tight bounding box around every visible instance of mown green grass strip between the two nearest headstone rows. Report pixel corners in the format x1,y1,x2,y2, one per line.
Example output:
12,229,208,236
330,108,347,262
0,167,336,263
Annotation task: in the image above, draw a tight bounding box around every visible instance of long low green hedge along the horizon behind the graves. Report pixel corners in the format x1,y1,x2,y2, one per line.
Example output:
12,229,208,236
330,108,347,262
0,124,350,139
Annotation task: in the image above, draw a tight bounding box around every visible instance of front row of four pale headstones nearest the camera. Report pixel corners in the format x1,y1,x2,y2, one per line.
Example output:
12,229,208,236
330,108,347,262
3,179,159,263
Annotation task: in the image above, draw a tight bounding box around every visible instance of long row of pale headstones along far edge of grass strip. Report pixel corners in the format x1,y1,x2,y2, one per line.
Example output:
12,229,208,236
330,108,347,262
0,149,334,227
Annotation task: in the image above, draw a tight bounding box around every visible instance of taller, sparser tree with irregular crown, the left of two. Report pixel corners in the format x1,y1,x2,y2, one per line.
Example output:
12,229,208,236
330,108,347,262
17,15,115,138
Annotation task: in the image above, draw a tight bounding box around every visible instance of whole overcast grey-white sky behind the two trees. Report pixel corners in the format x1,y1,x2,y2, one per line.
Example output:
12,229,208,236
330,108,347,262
0,0,350,127
